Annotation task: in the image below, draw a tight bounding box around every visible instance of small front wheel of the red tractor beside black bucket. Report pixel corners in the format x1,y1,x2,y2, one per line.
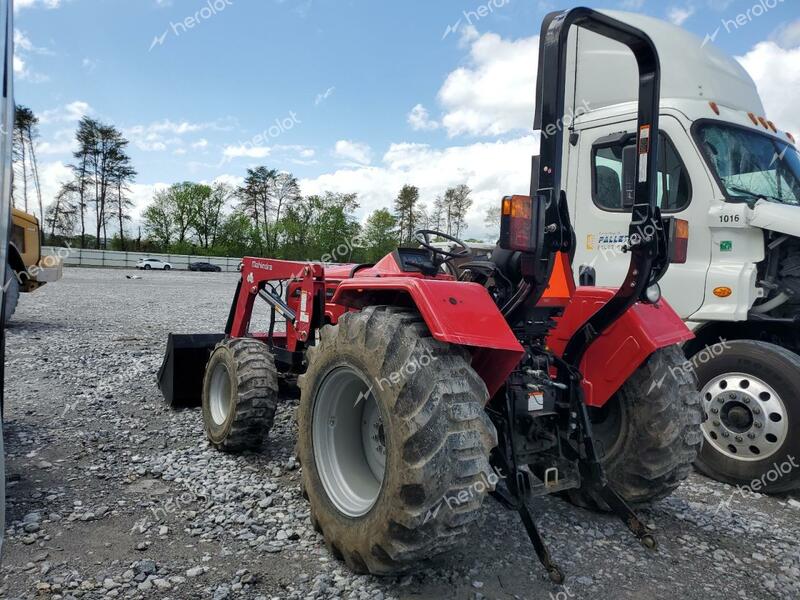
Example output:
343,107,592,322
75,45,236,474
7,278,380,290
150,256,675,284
203,338,278,452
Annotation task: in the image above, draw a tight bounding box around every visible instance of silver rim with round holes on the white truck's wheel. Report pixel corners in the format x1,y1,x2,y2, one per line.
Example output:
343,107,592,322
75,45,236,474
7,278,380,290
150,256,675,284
702,373,789,462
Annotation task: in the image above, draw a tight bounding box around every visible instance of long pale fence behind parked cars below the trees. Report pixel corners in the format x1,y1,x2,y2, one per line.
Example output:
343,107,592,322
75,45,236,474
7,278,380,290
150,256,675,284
42,246,242,272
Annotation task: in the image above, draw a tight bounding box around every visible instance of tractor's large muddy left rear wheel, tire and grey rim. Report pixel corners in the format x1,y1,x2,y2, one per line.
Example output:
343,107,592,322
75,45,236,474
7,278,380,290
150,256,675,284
298,307,497,575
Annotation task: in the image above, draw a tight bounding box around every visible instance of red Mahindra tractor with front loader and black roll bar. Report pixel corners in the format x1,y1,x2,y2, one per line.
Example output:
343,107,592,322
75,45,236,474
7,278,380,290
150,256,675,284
159,9,702,582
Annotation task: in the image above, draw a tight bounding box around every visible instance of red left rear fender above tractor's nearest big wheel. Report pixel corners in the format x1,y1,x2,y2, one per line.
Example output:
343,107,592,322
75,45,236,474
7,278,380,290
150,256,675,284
332,277,525,398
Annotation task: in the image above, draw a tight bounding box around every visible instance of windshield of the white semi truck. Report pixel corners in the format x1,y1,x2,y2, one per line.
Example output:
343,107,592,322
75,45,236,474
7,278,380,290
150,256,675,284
697,123,800,206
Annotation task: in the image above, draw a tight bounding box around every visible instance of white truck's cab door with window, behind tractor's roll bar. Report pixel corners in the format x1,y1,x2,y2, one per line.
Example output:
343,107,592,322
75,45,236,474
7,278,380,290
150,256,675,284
568,115,711,318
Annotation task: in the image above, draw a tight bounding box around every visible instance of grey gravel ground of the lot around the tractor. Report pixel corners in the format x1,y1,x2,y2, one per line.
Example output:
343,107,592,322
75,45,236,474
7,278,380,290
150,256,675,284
0,269,800,600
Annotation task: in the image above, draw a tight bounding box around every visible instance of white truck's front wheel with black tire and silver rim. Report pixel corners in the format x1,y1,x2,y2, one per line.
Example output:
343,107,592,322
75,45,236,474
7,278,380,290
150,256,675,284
693,340,800,494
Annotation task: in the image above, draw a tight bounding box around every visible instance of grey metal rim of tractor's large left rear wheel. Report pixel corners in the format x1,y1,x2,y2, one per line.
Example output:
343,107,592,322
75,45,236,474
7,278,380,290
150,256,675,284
311,367,386,518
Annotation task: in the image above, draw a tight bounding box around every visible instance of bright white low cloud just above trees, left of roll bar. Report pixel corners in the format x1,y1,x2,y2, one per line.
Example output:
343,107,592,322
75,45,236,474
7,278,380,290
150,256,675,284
300,134,539,237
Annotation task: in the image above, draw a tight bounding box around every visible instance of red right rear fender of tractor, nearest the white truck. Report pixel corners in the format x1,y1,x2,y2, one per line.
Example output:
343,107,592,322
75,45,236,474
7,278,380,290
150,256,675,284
547,287,694,407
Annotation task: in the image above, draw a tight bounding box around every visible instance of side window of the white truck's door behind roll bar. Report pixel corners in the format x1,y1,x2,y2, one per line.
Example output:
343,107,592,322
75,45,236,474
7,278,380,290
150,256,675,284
592,133,692,213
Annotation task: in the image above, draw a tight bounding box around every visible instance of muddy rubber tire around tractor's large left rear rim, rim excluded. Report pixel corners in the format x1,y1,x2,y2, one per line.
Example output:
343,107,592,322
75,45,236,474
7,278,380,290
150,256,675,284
299,306,497,575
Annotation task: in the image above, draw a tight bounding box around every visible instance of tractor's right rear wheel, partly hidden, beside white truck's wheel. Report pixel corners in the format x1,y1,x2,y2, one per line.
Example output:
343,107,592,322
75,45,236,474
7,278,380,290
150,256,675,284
569,346,703,510
